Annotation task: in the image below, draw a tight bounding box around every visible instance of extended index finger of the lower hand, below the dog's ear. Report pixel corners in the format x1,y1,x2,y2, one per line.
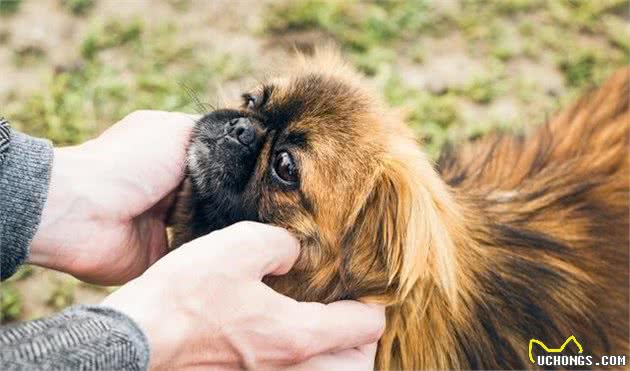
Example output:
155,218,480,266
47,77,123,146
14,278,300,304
290,300,385,355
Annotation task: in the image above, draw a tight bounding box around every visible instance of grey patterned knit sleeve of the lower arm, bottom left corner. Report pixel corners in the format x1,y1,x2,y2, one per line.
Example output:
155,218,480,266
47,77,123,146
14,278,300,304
0,305,149,371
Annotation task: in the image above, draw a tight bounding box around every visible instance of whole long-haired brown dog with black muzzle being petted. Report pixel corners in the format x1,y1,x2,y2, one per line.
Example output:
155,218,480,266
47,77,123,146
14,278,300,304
173,51,630,370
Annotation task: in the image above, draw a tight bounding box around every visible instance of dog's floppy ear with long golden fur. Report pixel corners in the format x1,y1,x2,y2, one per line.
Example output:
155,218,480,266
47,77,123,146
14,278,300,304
348,145,460,301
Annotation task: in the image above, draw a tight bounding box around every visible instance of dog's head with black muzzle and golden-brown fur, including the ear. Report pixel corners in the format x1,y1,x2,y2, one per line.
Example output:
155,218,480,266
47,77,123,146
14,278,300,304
183,51,454,303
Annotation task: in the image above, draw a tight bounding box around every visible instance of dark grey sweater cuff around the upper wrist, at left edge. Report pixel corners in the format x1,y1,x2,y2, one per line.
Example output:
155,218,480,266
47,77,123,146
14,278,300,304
0,131,53,279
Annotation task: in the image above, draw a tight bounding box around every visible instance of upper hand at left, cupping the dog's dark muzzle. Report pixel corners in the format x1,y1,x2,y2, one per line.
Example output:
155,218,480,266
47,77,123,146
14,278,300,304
28,111,196,285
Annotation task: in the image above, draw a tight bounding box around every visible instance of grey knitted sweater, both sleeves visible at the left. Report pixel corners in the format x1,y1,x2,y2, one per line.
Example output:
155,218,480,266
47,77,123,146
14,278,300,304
0,118,149,370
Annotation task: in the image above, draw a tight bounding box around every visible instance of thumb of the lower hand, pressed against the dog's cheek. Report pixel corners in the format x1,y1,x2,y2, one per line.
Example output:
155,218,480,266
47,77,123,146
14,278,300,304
195,222,300,280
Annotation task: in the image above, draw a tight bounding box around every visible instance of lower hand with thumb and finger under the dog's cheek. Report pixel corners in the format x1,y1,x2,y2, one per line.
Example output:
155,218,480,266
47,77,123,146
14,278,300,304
103,222,385,370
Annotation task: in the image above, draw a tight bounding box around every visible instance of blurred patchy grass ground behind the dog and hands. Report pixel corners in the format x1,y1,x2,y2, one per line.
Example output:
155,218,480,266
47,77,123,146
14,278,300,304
0,0,630,322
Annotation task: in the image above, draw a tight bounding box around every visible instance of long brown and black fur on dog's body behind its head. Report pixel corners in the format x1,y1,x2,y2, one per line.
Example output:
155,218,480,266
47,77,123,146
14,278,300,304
378,69,630,369
